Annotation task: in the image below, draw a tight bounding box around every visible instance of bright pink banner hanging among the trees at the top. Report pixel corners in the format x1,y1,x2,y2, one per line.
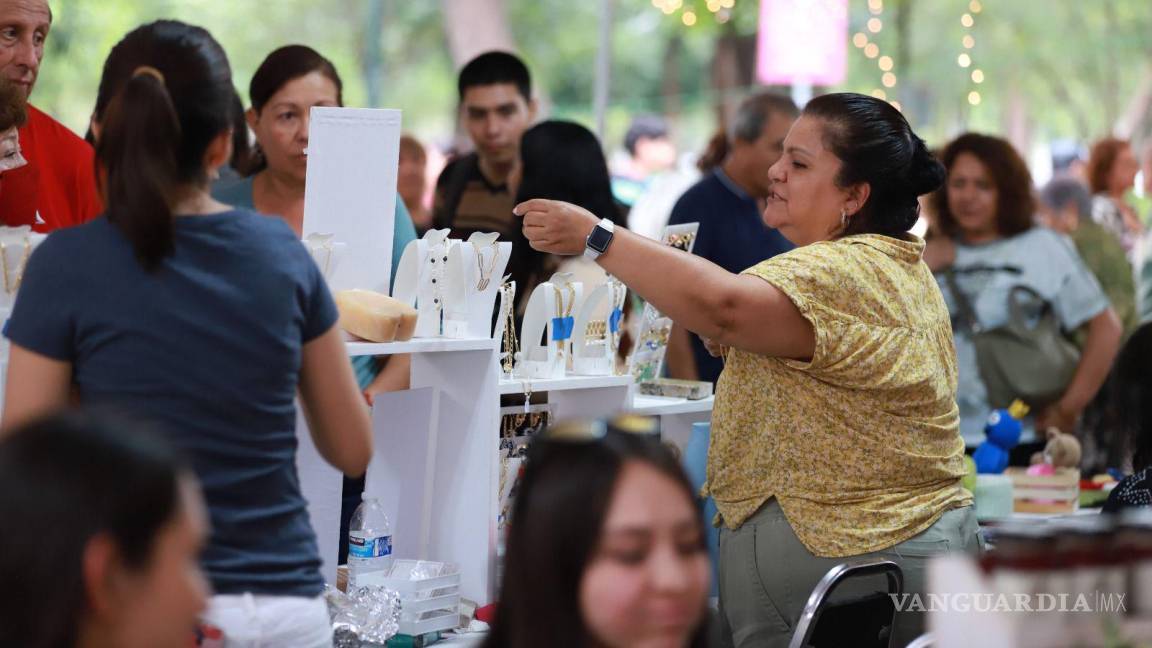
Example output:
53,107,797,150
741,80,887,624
756,0,848,85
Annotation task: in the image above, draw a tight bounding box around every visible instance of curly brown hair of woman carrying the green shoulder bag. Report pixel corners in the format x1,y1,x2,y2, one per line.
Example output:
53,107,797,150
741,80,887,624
933,133,1036,238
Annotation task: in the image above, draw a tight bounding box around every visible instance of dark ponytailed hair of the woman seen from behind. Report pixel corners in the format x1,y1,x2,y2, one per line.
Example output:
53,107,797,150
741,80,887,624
93,21,235,271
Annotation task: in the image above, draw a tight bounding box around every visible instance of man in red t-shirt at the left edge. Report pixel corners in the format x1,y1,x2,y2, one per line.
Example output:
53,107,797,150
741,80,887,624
0,0,104,232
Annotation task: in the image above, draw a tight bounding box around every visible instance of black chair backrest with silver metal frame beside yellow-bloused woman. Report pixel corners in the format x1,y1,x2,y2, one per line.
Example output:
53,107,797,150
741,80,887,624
788,560,904,648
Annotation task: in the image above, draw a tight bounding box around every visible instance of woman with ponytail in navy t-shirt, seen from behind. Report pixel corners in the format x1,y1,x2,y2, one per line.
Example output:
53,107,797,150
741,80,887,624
3,21,371,647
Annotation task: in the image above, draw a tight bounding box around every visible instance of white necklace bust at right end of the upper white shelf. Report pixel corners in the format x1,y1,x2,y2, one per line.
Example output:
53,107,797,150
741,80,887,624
444,232,511,339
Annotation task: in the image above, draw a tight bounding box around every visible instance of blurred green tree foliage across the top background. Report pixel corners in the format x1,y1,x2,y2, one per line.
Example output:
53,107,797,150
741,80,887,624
33,0,1152,156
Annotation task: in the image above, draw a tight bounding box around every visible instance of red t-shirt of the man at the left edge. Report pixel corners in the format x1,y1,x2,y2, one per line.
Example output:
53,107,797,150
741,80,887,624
0,106,104,232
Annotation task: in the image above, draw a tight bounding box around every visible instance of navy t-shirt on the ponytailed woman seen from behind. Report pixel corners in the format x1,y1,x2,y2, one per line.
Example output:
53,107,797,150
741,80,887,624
6,210,338,596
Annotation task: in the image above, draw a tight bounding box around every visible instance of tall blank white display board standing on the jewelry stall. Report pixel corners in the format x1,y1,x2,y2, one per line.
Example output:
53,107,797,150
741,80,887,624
303,107,400,294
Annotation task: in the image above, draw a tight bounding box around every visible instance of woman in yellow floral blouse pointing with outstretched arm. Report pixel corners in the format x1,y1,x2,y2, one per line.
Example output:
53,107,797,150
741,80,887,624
516,93,982,647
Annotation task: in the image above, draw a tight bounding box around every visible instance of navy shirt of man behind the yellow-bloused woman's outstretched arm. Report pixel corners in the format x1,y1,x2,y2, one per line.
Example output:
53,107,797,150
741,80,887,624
668,168,796,383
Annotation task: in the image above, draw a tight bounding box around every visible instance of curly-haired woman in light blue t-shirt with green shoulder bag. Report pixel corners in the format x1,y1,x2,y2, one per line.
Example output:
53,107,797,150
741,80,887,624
924,133,1121,446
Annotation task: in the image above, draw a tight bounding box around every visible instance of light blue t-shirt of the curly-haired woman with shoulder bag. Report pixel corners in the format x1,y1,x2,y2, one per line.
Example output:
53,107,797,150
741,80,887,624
937,227,1108,446
